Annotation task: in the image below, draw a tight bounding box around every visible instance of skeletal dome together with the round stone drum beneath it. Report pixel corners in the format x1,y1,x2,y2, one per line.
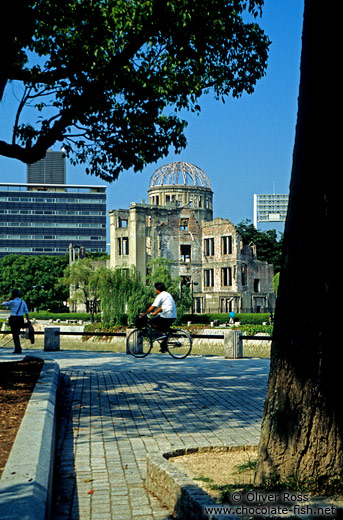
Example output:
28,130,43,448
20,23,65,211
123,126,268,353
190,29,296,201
148,162,213,220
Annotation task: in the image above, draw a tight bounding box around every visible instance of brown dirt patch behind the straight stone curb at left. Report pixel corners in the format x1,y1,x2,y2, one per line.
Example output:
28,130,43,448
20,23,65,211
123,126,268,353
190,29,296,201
0,360,43,478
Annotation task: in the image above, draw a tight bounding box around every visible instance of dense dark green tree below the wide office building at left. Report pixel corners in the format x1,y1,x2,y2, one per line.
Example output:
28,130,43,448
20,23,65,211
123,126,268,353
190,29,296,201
0,255,69,311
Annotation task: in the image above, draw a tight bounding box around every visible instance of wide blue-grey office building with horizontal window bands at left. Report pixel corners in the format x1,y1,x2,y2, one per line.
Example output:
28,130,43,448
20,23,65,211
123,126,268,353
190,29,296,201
0,179,106,257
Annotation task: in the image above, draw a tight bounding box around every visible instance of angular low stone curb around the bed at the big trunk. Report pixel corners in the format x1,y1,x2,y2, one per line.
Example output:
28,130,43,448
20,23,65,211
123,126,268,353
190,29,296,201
145,446,243,520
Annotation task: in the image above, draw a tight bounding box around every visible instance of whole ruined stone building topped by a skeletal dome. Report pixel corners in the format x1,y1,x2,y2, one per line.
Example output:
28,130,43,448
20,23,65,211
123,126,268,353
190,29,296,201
110,162,275,313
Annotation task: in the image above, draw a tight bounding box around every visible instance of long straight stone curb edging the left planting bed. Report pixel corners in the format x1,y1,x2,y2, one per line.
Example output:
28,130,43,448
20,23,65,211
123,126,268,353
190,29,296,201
0,356,60,520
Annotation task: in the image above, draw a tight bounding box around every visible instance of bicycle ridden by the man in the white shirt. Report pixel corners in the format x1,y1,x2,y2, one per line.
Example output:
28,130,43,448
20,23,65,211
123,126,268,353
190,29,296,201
126,314,192,359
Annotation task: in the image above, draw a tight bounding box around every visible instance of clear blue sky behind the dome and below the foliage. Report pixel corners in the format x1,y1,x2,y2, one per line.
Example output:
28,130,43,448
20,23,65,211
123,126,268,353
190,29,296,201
0,0,304,237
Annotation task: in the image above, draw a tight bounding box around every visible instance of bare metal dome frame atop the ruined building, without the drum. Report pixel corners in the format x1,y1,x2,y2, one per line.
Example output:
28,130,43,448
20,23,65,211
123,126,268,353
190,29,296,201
150,162,212,190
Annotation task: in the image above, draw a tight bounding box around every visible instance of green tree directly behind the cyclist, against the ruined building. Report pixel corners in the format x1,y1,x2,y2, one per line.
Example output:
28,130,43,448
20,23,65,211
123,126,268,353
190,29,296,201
147,258,192,323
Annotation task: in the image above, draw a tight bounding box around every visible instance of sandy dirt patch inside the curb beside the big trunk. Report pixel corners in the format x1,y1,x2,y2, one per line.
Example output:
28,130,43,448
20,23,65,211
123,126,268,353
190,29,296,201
168,447,257,499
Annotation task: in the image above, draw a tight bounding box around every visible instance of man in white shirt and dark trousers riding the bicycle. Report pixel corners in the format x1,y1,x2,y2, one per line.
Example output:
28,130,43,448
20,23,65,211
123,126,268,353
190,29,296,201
139,282,176,352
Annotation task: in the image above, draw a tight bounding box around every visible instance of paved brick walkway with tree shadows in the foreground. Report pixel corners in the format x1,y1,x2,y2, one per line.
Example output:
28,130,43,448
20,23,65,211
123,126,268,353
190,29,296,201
0,350,269,520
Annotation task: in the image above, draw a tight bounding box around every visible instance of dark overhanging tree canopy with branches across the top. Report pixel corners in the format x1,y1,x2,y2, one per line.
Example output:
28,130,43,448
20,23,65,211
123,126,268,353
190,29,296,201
0,0,269,181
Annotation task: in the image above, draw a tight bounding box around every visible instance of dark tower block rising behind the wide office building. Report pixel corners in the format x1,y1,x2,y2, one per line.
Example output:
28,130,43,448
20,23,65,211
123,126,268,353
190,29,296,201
26,150,66,184
